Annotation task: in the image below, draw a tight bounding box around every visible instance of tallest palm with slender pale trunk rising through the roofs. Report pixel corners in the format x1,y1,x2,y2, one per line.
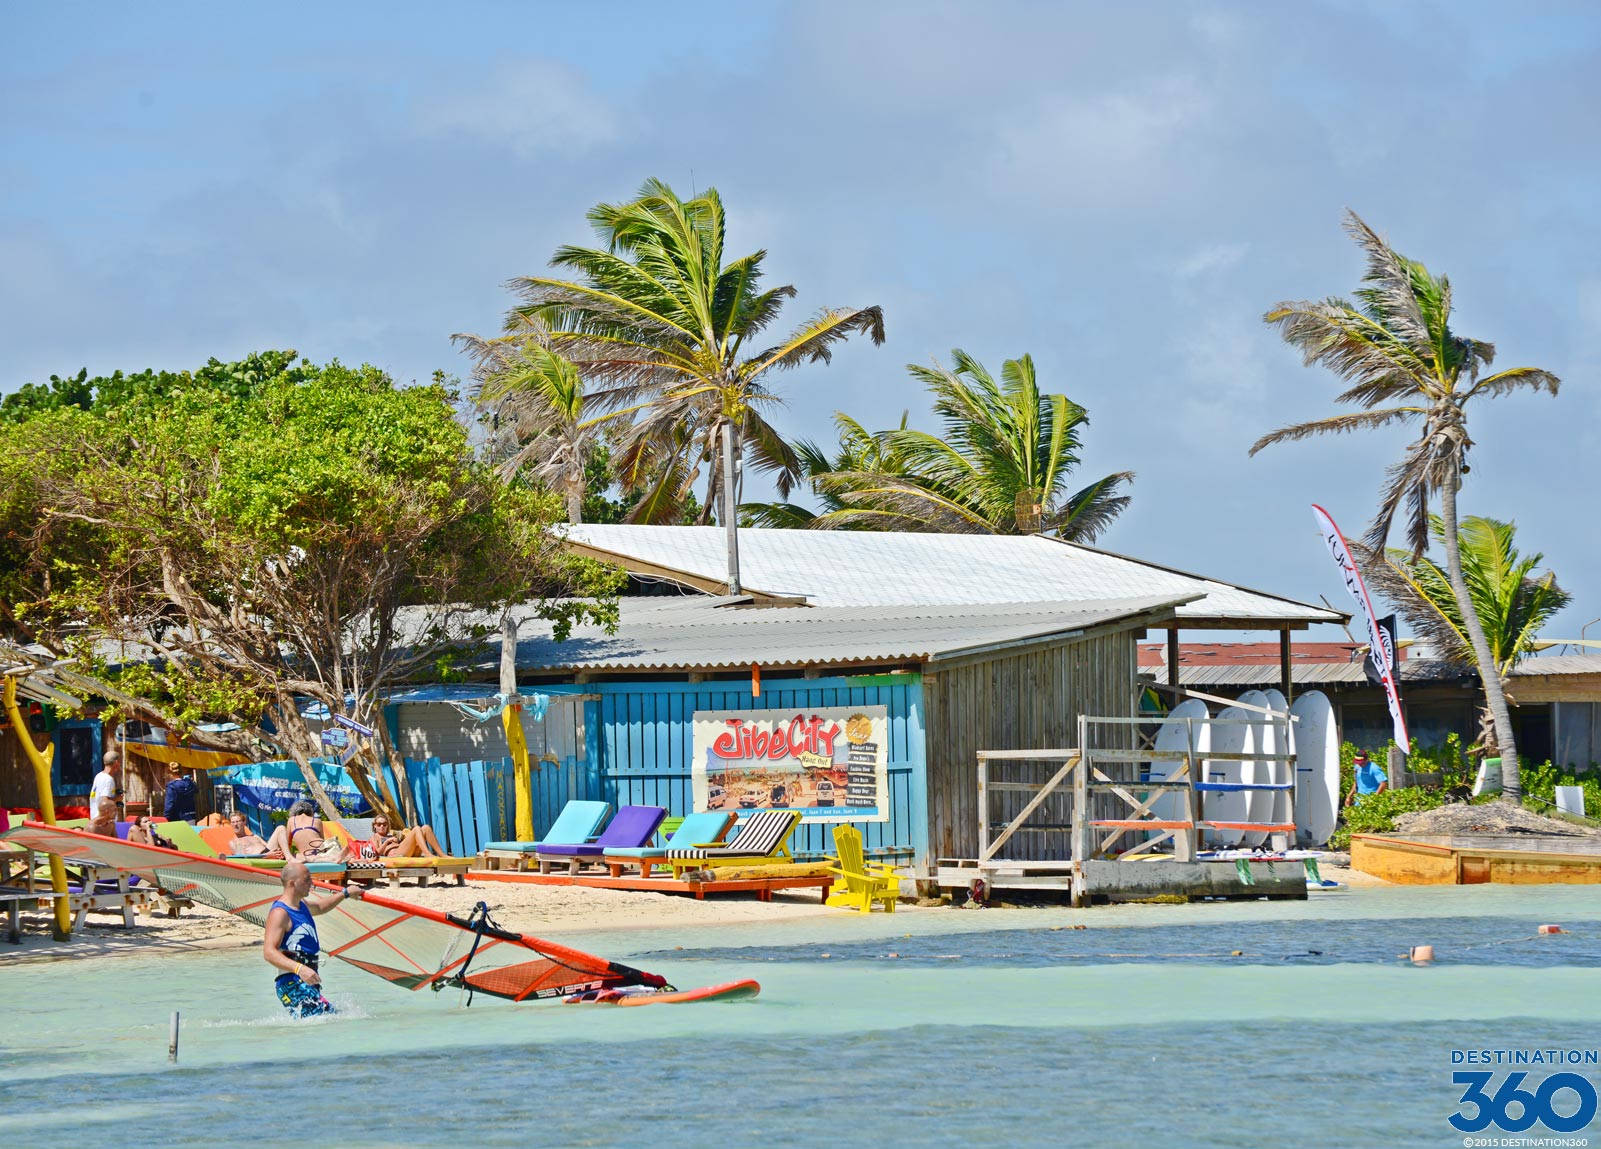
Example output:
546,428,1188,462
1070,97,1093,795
508,179,884,594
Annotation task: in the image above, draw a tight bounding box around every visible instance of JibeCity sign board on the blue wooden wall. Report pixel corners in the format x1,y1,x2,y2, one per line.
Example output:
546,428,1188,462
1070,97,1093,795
692,706,890,823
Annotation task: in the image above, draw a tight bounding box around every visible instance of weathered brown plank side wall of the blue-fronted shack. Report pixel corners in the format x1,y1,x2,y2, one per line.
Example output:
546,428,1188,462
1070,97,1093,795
922,631,1140,858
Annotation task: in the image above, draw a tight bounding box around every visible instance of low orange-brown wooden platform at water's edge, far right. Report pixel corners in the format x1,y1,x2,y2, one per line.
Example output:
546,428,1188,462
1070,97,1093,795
1351,834,1601,885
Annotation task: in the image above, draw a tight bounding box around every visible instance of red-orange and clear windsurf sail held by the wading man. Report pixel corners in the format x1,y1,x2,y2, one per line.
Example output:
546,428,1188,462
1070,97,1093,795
0,823,666,1002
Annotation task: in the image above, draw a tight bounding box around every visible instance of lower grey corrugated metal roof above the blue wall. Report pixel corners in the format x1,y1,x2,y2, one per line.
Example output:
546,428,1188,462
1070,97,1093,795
496,595,1178,671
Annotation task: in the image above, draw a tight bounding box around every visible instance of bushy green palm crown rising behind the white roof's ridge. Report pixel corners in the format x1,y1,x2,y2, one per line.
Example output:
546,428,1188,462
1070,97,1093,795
815,347,1134,541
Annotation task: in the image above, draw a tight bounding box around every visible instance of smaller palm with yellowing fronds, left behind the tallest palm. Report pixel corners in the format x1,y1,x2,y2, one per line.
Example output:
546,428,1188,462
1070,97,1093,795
467,334,615,523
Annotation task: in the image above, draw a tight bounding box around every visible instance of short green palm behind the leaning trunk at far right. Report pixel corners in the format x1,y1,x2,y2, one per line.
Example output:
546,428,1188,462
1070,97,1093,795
1358,515,1572,746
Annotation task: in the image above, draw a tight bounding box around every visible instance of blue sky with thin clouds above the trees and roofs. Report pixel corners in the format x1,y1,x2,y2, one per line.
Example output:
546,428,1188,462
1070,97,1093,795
0,0,1601,639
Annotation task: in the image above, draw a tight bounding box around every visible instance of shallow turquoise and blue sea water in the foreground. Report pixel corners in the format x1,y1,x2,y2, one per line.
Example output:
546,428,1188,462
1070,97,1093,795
0,887,1601,1147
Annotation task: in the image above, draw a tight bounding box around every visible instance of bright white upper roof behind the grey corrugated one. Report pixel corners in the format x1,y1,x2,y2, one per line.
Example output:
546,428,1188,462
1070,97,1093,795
564,523,1343,626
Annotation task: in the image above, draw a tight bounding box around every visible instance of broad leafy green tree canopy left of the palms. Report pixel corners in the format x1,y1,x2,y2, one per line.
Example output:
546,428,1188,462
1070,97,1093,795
0,352,616,825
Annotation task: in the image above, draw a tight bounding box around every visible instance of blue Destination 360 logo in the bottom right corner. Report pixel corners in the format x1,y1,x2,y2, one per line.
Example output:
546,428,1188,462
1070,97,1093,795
1447,1048,1601,1149
